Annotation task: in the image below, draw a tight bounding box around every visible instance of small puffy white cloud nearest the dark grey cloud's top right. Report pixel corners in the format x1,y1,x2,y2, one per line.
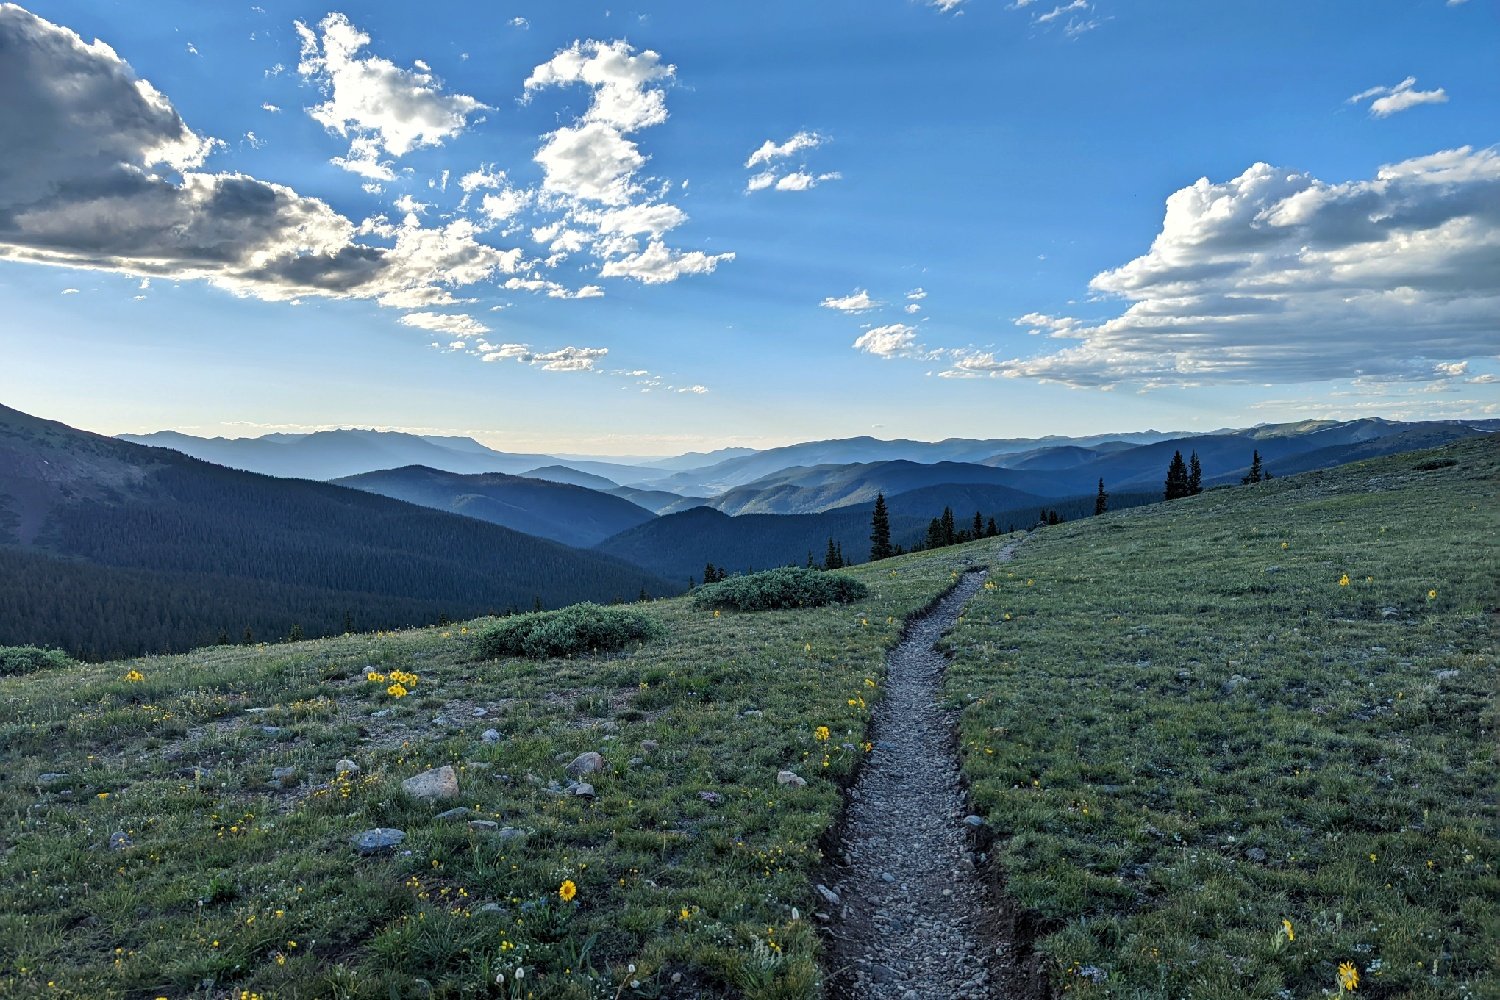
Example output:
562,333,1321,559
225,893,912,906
296,13,486,180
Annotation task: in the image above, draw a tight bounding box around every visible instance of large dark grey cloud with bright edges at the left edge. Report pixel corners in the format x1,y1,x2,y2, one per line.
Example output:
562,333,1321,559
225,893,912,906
0,4,522,309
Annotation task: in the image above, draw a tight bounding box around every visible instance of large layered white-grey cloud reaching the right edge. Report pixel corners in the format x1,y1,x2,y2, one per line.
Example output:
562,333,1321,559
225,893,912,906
950,147,1500,387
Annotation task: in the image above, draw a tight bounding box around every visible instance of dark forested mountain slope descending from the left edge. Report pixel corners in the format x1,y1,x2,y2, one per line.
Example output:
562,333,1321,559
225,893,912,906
0,406,681,657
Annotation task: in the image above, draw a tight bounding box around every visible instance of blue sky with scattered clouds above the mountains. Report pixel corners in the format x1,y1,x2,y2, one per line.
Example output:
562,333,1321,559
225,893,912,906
0,0,1500,456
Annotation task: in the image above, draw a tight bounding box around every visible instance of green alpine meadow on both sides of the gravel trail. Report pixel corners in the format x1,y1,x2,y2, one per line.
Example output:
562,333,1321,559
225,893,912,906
0,441,1500,1000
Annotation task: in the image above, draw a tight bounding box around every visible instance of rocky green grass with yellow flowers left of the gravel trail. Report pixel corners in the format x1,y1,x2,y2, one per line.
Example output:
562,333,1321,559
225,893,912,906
0,550,975,1000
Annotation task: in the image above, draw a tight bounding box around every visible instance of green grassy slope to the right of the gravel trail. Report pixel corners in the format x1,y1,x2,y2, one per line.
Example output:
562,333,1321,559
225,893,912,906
948,439,1500,1000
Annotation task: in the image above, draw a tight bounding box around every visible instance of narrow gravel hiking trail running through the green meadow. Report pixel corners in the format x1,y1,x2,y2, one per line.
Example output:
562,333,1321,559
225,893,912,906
824,541,1019,1000
